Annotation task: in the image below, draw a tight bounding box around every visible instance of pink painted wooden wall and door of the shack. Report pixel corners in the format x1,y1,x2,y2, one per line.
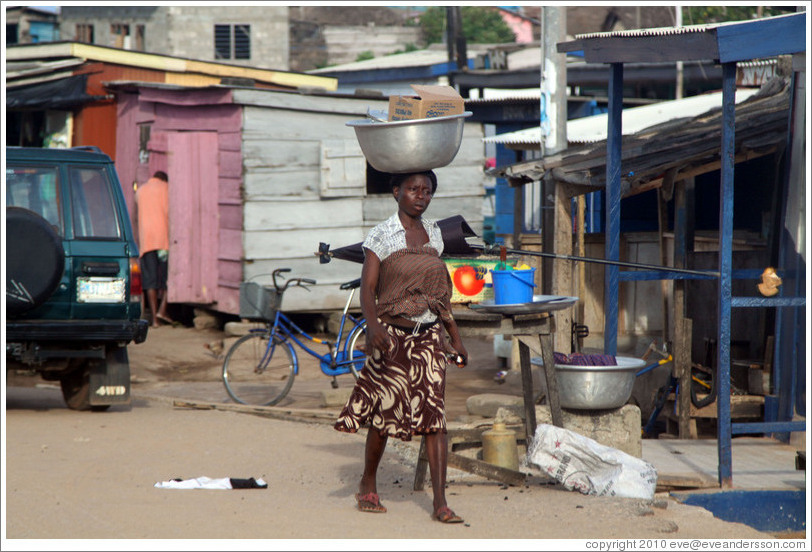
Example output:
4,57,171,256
116,88,243,314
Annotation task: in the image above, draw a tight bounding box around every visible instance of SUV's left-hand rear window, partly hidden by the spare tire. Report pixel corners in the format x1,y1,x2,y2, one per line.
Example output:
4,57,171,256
6,165,64,235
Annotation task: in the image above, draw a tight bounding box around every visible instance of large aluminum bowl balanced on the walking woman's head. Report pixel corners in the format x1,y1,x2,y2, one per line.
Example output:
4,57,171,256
346,111,472,173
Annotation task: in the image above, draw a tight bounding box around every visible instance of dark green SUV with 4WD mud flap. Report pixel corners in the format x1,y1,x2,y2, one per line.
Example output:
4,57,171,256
5,147,148,410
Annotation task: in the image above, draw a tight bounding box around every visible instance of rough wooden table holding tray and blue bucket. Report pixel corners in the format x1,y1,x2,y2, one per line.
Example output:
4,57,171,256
414,302,572,491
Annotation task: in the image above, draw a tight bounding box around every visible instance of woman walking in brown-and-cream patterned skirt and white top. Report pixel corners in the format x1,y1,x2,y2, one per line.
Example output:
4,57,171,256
335,171,468,523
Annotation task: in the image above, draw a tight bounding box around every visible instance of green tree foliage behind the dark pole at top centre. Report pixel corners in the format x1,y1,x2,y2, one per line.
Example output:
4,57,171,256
420,6,516,44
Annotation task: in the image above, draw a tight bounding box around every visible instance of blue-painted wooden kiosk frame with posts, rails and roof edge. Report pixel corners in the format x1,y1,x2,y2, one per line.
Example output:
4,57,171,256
558,12,808,488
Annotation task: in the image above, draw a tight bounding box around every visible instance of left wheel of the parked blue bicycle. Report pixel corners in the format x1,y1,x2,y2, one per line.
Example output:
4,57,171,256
223,332,296,406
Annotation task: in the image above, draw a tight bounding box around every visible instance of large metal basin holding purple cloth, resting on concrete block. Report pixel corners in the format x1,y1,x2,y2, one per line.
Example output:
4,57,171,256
530,356,646,410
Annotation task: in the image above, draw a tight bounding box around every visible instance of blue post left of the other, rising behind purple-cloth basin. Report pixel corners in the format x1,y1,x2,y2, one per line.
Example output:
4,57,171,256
603,63,623,355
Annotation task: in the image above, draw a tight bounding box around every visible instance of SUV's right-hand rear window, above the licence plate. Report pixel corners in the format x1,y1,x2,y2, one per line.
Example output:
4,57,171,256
69,167,119,238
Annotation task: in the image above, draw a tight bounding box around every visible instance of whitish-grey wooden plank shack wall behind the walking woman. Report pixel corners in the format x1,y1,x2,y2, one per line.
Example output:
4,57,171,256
234,89,485,312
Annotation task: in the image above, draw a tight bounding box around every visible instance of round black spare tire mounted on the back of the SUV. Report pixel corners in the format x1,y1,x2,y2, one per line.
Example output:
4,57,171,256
6,206,65,315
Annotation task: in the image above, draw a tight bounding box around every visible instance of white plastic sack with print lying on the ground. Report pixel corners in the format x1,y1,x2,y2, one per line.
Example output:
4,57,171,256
527,424,657,500
